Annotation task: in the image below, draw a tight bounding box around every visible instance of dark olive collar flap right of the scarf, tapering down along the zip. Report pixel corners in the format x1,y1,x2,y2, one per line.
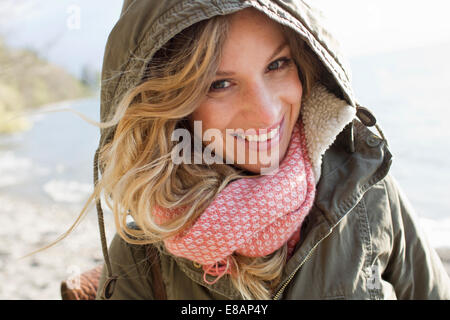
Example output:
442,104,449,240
275,120,392,299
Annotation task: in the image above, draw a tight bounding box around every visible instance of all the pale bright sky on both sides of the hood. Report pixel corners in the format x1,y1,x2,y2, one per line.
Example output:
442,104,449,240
0,0,450,74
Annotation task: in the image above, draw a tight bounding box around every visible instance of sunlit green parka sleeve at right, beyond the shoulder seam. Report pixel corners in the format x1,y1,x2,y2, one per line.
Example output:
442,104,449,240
363,174,450,299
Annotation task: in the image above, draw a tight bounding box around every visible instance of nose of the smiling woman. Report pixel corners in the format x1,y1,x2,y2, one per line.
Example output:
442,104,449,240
242,82,282,129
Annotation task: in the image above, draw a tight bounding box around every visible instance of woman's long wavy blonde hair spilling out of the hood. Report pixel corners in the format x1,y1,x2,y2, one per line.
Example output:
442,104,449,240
37,11,320,299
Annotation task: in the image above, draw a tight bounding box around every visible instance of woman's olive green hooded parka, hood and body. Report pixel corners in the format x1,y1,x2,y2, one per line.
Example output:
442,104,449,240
94,0,450,300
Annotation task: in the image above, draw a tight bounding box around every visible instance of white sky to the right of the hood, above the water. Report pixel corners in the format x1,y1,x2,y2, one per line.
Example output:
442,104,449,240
313,0,450,57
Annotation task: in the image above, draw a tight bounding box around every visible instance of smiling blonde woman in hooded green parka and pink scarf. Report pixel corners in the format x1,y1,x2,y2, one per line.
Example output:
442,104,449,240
77,0,450,299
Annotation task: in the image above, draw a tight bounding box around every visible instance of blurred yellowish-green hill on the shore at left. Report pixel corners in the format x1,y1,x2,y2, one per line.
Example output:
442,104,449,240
0,39,93,134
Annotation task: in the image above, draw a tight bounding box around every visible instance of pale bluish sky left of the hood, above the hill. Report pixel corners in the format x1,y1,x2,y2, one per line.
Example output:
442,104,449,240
0,0,122,75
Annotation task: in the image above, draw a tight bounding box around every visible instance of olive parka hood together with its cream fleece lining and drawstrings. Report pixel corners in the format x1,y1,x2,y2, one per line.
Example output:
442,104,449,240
94,0,382,295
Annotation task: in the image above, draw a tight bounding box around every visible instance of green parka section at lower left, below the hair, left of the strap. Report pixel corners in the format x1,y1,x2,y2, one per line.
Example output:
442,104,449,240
96,233,153,300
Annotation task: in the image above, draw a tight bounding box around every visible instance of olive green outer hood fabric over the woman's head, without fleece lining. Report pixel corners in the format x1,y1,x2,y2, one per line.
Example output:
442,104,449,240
100,0,356,146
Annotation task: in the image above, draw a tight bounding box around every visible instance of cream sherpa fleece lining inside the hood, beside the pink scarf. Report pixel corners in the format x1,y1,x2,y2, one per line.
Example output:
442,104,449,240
301,84,356,184
